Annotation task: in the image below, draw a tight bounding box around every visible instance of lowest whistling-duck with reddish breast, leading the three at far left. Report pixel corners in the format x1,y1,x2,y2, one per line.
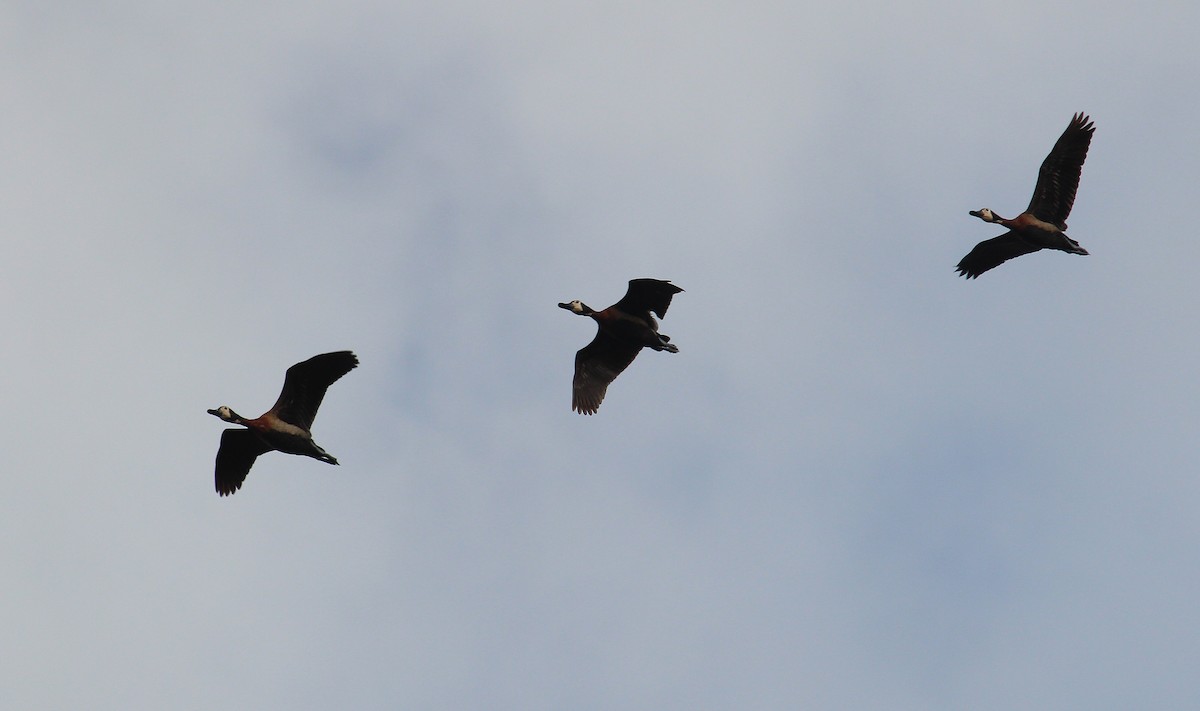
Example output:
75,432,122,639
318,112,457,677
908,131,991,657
209,351,359,496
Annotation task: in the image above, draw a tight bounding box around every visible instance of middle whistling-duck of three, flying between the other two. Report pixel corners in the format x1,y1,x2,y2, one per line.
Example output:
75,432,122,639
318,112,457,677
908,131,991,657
559,279,683,414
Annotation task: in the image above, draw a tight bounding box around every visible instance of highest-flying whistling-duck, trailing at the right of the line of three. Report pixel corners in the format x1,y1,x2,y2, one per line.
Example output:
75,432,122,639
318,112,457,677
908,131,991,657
958,113,1096,279
